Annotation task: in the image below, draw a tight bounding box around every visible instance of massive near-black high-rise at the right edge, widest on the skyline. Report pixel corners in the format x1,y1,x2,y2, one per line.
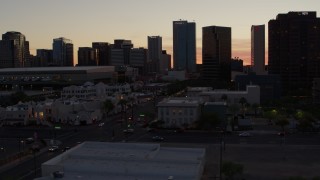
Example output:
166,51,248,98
268,12,320,93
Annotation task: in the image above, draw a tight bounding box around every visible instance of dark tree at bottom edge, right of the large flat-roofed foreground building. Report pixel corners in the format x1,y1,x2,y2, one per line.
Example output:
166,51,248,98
221,161,244,179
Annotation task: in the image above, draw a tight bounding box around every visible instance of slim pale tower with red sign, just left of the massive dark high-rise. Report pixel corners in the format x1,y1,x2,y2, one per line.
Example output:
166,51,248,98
251,25,265,75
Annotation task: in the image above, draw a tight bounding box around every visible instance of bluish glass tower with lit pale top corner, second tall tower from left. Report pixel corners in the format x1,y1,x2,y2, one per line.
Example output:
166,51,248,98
52,37,73,66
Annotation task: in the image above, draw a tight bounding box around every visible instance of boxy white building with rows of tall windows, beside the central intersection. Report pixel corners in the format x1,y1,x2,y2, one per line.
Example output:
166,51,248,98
157,98,202,128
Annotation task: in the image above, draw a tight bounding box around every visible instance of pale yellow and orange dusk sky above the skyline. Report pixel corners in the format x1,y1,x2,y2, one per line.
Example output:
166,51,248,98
0,0,320,64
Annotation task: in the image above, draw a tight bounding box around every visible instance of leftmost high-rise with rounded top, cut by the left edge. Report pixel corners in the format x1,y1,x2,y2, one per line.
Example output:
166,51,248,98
0,31,30,68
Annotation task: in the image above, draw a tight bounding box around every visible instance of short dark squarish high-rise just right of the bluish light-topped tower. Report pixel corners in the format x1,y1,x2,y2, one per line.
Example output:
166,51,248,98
78,47,98,66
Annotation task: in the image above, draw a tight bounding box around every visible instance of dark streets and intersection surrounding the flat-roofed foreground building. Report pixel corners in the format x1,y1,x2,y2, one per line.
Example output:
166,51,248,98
0,102,320,180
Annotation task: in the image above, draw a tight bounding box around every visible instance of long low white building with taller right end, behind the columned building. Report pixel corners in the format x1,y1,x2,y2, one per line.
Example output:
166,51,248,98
199,85,260,104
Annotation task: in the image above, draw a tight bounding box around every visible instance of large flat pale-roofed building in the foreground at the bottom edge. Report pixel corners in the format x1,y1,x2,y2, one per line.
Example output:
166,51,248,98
37,142,205,180
